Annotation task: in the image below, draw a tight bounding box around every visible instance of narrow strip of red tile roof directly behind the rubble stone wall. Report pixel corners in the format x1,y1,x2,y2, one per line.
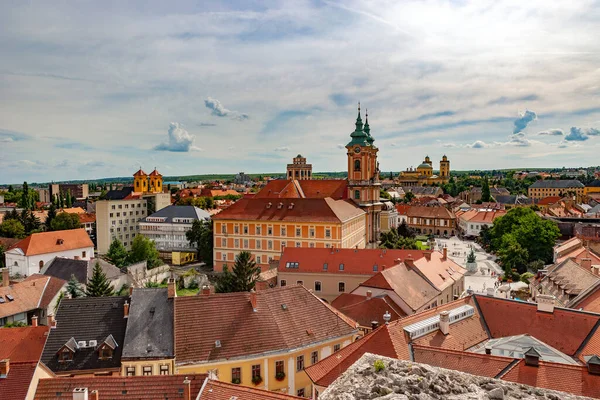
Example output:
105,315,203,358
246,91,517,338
413,344,514,378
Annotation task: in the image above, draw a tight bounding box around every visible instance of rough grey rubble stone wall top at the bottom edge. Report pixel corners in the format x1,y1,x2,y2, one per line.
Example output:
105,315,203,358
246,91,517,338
319,354,589,400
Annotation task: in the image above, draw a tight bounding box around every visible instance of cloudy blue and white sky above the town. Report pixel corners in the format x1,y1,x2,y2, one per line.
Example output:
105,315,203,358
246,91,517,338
0,0,600,183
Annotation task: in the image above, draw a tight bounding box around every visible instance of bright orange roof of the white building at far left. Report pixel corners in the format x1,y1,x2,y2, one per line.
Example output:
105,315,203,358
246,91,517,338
8,228,94,256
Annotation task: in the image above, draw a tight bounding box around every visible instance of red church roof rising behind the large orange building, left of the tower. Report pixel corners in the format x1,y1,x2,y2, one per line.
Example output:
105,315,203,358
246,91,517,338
255,179,348,200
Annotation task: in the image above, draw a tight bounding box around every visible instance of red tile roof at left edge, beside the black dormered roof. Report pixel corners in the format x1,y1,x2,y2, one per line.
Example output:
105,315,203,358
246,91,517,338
0,326,50,362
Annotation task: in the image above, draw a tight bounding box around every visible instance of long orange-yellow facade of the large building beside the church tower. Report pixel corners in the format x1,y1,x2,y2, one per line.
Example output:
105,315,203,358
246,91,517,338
213,214,366,272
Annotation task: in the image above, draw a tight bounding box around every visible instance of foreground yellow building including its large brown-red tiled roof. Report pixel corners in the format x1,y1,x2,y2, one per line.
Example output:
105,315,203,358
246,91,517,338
175,286,359,397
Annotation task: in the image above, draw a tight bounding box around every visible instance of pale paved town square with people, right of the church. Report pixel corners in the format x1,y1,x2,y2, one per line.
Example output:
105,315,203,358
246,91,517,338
436,236,502,293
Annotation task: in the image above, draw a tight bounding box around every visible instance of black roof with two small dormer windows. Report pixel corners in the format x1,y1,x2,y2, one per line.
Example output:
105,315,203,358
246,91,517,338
42,297,127,373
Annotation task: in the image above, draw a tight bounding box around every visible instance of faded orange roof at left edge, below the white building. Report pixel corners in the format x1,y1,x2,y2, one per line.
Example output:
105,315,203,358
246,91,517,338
0,274,67,318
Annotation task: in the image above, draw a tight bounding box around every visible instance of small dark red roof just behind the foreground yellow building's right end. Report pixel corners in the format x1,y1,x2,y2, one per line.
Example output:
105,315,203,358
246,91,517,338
331,293,406,328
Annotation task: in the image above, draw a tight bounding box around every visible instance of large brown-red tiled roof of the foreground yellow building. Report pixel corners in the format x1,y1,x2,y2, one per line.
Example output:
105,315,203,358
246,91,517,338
175,286,356,364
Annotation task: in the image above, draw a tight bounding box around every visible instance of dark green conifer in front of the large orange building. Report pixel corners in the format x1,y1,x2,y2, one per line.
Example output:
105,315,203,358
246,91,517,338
215,251,260,293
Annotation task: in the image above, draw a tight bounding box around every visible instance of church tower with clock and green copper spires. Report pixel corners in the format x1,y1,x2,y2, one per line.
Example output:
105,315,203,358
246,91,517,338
346,103,383,247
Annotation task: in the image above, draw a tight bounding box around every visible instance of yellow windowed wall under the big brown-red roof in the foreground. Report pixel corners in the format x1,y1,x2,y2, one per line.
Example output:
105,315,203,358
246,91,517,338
176,333,358,397
